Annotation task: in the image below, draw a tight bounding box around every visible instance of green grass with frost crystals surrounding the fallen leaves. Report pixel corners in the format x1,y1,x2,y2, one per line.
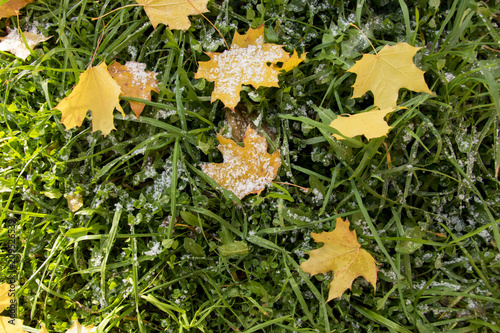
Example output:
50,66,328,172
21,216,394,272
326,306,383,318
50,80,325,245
0,0,500,333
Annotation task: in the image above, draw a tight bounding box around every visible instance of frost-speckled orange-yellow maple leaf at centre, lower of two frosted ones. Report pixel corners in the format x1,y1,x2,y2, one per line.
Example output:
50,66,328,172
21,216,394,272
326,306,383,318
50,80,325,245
201,127,281,199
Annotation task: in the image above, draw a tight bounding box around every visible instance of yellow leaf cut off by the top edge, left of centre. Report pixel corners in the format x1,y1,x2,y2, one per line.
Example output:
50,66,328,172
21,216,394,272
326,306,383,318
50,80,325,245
135,0,208,30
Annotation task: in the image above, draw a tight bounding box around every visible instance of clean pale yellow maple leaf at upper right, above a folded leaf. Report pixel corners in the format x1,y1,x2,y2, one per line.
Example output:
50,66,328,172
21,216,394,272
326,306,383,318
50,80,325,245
348,43,432,109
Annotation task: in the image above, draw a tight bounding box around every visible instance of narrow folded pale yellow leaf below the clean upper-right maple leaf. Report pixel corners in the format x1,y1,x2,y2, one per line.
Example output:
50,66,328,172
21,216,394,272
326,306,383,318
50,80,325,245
330,108,394,140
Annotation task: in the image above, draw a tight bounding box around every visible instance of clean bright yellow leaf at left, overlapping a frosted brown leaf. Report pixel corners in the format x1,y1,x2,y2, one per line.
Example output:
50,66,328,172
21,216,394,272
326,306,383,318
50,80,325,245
55,62,125,135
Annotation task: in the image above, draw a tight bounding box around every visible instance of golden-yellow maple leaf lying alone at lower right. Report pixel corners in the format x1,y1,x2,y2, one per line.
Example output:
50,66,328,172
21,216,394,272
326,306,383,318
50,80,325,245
300,218,378,302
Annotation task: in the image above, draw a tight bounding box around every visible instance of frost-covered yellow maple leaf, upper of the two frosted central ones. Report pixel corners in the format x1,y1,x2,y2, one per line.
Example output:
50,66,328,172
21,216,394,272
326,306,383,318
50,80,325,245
194,25,290,110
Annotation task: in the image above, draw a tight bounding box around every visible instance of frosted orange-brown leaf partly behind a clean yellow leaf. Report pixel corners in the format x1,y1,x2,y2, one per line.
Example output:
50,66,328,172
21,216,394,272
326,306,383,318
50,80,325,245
108,61,159,119
